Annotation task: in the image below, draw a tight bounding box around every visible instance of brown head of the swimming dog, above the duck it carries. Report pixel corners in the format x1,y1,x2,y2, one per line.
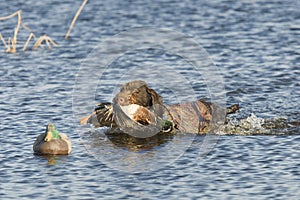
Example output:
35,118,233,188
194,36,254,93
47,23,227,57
114,81,163,108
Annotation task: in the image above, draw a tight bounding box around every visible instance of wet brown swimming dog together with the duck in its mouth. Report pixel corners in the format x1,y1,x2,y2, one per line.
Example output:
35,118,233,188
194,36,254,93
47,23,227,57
80,81,239,134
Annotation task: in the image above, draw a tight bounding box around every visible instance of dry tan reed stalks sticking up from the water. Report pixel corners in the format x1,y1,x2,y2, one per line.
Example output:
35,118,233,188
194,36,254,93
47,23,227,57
0,0,88,53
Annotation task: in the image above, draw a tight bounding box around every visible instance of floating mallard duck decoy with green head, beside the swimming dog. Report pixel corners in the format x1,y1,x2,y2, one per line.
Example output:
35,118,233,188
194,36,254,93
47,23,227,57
33,124,72,155
